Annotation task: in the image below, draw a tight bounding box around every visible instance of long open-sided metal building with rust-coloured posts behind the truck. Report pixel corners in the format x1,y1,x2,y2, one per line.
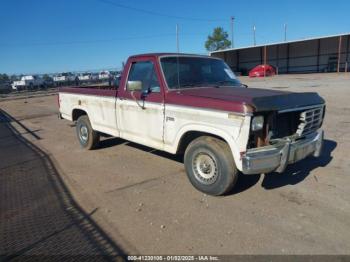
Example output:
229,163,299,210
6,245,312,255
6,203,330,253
210,34,350,75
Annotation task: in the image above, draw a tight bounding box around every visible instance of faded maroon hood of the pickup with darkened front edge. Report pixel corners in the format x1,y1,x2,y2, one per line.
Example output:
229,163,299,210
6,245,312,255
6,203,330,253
178,87,325,112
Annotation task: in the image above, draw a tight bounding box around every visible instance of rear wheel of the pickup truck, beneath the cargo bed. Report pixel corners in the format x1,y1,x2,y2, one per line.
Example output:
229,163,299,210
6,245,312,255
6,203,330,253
76,115,100,150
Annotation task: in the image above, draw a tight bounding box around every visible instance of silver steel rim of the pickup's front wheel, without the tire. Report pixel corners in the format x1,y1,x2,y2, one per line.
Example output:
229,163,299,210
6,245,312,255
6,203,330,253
192,153,219,185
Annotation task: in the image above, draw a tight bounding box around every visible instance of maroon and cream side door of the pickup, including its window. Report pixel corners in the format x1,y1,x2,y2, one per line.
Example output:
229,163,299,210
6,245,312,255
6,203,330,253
117,58,164,149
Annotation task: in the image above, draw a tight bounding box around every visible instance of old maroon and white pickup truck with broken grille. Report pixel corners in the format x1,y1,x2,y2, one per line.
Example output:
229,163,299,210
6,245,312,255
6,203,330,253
59,53,325,195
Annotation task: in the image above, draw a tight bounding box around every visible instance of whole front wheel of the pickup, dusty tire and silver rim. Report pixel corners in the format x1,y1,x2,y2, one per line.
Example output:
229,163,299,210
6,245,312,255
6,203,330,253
184,136,238,196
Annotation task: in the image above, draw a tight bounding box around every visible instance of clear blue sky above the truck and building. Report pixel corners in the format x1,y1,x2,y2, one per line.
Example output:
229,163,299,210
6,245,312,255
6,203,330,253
0,0,350,74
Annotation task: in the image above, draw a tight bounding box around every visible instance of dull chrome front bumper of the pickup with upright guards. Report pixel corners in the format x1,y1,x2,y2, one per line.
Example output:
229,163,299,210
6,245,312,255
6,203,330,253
242,130,323,174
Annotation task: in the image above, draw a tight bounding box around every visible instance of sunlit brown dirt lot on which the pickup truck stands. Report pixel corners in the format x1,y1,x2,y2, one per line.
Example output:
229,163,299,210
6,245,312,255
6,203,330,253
0,74,350,254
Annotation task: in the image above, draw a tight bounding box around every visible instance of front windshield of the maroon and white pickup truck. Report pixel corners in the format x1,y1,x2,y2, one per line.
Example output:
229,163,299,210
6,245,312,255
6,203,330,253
160,56,241,89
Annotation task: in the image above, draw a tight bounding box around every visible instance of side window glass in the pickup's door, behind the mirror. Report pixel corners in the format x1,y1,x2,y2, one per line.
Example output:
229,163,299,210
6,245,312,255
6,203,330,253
128,61,160,93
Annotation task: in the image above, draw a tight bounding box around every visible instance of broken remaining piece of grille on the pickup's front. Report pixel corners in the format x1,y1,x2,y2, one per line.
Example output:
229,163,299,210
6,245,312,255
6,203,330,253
296,106,324,136
